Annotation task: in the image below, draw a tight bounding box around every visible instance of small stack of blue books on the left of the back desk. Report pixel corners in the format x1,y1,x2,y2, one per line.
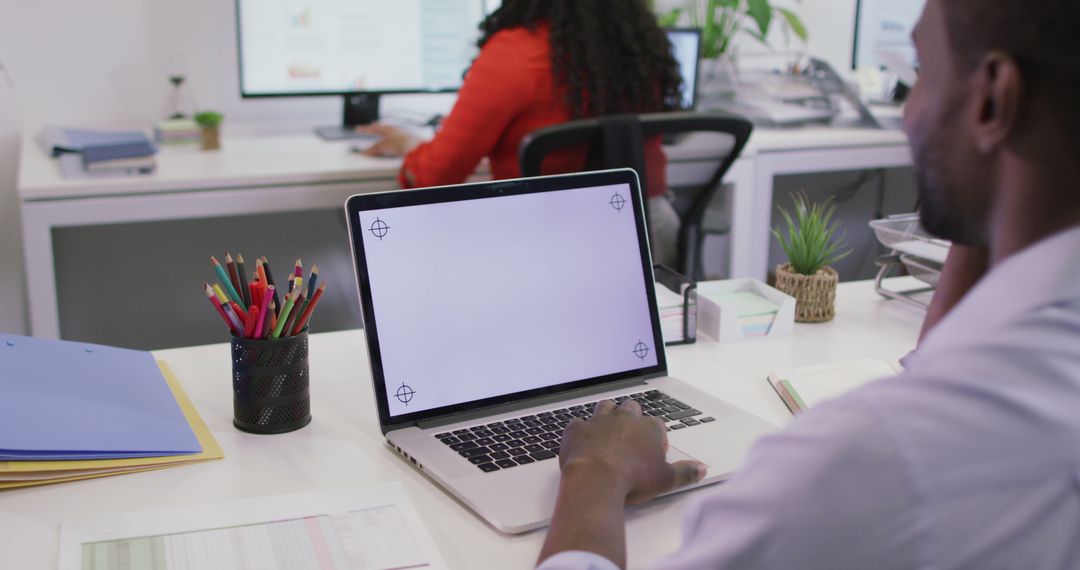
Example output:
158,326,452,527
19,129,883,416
43,127,158,178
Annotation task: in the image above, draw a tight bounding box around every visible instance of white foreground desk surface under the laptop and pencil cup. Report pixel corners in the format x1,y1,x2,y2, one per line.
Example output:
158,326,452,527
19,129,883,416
0,282,923,570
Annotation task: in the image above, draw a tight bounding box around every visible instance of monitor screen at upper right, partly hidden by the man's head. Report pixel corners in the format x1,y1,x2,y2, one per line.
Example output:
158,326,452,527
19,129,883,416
851,0,926,69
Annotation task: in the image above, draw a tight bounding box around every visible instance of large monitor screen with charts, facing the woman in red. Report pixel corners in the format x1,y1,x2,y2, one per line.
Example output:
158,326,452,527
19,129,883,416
237,0,484,96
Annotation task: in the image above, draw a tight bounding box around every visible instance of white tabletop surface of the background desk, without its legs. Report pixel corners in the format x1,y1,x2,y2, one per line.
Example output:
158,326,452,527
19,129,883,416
17,126,907,202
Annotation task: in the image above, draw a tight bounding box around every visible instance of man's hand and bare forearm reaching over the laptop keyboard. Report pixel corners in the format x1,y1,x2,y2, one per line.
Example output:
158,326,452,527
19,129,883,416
539,399,705,568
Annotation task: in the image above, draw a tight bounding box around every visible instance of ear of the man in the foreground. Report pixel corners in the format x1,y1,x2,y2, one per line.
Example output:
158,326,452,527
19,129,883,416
972,52,1025,153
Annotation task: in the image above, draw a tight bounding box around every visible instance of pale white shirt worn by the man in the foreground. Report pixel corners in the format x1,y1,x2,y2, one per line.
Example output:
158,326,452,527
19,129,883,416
540,227,1080,570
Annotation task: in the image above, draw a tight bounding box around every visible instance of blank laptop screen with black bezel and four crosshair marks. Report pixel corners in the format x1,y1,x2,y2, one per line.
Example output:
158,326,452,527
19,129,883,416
348,171,665,424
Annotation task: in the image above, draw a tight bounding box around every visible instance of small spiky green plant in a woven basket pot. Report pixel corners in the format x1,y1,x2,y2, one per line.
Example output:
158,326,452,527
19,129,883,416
772,192,851,323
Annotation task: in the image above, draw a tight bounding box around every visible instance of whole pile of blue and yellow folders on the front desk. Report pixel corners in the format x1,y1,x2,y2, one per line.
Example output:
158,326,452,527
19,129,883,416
0,334,224,490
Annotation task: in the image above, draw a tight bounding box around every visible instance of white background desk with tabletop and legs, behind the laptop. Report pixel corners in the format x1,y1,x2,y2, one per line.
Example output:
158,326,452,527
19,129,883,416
17,127,910,338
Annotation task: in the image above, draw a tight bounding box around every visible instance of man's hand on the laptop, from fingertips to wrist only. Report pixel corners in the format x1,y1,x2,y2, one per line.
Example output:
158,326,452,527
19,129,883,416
559,399,705,504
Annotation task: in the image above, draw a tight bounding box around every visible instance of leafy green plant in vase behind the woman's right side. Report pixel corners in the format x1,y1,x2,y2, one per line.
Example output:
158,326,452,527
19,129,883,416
660,0,808,95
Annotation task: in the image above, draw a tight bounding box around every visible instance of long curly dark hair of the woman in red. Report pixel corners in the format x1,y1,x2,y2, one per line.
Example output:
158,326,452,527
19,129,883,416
477,0,683,118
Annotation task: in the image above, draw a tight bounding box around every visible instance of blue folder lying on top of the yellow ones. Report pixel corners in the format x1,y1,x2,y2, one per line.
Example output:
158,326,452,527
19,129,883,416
0,334,202,461
